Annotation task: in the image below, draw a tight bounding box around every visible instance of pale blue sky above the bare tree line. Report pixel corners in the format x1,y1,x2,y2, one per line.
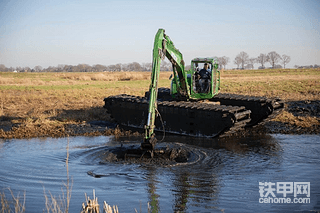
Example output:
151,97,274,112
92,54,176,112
0,0,320,68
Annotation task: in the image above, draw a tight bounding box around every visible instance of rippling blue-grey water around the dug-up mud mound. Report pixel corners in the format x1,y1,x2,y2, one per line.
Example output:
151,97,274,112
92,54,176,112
0,135,320,212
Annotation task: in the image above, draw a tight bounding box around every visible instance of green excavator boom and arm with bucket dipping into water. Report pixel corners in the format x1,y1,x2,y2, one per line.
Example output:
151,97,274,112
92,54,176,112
141,29,190,150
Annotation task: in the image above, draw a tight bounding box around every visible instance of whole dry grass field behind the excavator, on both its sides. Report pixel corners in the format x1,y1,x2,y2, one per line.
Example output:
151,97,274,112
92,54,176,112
0,68,320,138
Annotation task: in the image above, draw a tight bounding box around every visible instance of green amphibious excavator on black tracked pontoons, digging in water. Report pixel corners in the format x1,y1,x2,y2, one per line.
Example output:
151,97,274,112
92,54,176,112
104,29,284,150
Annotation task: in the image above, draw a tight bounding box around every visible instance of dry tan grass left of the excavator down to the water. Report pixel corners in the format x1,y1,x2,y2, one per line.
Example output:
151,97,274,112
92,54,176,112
0,72,169,138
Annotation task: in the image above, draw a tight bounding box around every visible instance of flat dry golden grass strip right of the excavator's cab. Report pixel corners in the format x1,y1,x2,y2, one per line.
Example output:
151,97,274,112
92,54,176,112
221,69,320,100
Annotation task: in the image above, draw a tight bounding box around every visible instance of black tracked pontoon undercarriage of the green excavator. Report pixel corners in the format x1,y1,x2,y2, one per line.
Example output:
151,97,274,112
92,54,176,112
104,88,284,137
